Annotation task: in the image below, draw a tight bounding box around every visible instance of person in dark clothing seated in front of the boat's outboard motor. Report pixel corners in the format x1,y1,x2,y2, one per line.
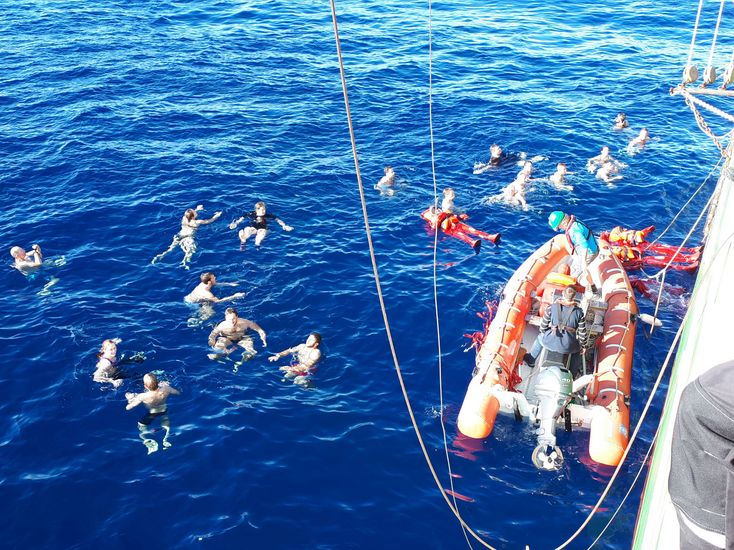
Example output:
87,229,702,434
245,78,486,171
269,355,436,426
525,286,588,374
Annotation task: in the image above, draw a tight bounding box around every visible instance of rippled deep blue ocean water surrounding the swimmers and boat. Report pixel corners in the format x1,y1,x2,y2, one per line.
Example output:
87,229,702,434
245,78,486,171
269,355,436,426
0,0,728,548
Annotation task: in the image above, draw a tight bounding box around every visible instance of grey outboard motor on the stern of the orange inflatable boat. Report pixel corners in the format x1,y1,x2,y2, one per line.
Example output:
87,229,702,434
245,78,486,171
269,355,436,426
527,349,573,470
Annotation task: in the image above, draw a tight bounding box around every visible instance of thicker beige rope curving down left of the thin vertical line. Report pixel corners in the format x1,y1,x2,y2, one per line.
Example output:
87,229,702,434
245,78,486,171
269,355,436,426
330,0,494,550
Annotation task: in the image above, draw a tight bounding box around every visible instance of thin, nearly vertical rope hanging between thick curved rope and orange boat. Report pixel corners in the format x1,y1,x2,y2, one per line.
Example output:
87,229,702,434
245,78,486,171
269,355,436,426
428,0,472,548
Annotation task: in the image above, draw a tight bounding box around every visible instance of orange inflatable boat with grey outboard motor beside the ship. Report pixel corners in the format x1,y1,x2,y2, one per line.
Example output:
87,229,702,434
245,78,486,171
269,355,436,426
458,235,638,469
